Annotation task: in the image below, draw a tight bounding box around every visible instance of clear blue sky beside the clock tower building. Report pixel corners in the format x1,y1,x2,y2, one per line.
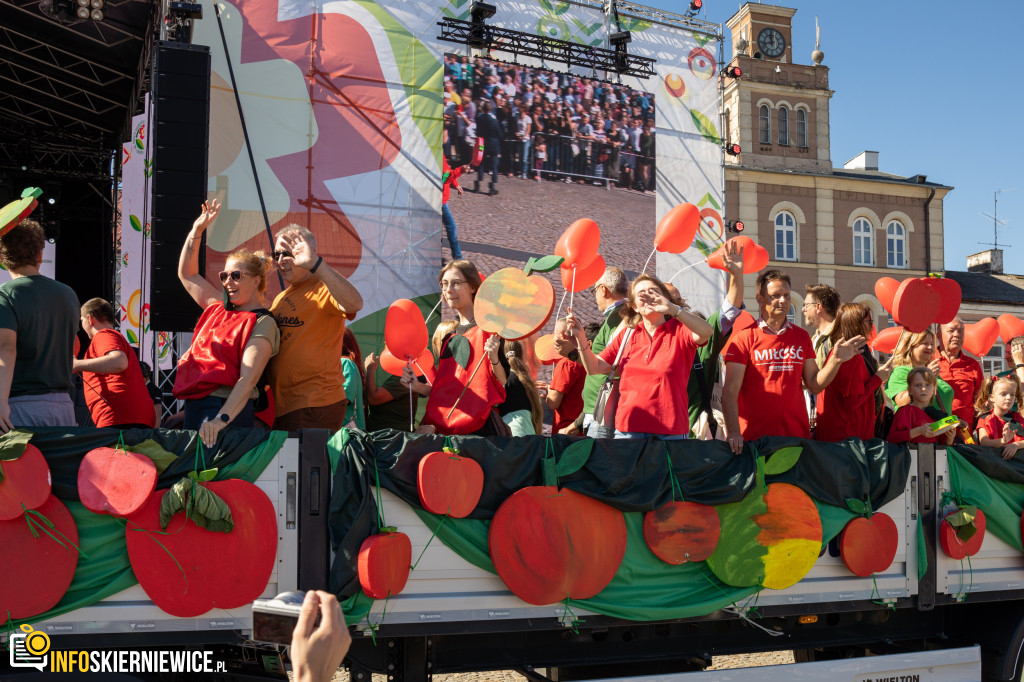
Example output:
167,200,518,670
639,0,1024,274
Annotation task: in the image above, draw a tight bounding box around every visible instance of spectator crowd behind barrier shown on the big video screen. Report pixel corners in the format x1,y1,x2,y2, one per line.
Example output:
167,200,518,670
443,54,655,193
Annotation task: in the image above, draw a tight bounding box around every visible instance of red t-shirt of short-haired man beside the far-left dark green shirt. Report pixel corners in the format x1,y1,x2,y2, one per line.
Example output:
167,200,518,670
82,329,157,428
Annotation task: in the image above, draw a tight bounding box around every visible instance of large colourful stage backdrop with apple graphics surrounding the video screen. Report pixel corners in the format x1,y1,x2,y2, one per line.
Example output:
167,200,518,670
194,0,724,352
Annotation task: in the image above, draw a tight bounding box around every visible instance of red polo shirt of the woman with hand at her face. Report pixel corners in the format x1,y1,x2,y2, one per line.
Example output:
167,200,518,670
599,318,697,435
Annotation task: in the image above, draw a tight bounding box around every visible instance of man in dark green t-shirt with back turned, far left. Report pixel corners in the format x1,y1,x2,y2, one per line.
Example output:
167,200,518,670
0,220,79,433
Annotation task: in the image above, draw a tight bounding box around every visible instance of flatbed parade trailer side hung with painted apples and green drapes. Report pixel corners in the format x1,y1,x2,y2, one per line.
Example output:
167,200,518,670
0,429,1024,682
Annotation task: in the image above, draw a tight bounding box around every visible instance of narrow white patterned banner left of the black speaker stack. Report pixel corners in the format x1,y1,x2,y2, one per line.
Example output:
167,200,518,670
118,95,171,369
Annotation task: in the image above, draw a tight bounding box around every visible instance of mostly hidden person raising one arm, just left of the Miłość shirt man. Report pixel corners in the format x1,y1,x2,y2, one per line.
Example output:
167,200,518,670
686,242,743,438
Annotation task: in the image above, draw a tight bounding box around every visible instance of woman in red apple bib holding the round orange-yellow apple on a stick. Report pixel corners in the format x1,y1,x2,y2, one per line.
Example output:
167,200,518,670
401,260,509,435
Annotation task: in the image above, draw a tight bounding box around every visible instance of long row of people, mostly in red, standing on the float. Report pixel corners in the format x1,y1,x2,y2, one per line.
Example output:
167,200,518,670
0,200,1024,459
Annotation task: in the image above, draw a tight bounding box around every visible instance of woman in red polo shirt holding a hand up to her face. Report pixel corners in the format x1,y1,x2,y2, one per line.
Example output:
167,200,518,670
566,274,712,440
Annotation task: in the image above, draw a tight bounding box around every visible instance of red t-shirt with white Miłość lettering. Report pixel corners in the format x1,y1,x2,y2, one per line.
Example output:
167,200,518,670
725,324,814,440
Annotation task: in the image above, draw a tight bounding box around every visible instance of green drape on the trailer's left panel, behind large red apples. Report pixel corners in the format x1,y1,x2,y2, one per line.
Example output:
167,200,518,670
3,428,288,628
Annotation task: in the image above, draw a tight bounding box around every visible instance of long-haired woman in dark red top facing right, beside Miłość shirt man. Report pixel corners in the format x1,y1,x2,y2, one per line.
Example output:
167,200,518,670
814,303,892,441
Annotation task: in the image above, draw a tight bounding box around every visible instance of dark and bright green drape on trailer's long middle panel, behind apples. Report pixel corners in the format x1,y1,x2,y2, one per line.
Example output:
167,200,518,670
328,431,909,623
